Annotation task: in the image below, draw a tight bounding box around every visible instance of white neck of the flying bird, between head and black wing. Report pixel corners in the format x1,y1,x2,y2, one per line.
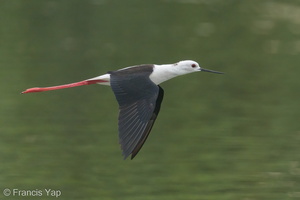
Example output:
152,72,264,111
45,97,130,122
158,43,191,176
150,64,180,85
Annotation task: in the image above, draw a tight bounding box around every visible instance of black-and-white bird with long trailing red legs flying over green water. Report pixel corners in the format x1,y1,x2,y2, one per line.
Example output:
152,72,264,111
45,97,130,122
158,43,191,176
22,60,223,159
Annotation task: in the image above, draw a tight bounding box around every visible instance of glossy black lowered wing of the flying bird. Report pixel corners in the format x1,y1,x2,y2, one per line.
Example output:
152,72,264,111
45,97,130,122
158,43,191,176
110,70,163,159
